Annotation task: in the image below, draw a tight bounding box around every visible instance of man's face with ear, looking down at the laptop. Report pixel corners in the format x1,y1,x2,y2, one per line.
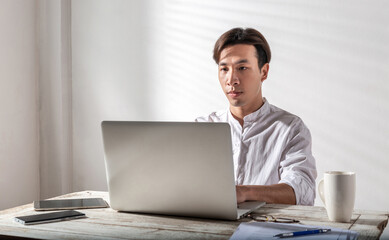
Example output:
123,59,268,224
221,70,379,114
219,44,269,111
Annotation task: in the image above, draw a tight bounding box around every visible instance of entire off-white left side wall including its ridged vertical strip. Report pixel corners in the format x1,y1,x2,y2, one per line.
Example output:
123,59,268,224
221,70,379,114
0,0,73,209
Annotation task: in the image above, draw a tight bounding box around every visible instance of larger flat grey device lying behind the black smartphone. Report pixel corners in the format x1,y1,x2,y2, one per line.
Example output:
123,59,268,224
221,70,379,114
34,198,109,211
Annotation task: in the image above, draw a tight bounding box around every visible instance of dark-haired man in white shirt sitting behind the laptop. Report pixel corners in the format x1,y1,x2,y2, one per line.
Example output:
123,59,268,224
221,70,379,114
196,28,317,205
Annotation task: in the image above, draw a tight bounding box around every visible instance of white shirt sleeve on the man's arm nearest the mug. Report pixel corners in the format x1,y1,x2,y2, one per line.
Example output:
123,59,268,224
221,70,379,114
279,119,317,205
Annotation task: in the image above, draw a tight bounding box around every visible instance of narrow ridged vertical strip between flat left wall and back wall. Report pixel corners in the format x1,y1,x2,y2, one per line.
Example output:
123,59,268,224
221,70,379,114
37,0,73,198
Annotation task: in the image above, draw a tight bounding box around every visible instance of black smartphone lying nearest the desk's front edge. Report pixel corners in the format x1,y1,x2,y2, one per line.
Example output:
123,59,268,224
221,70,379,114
15,210,86,225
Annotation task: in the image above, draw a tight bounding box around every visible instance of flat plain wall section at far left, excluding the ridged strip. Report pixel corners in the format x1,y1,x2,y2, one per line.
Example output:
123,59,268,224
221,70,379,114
0,0,39,209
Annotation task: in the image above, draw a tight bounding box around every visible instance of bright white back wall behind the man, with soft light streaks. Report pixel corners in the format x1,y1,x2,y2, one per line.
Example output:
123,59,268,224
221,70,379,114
72,0,389,210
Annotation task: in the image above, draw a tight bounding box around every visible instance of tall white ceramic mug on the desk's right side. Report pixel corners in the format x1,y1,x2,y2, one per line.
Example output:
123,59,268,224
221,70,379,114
319,171,355,222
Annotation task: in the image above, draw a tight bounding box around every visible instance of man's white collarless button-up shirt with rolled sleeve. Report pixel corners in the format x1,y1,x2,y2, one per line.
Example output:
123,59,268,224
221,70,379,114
196,98,317,205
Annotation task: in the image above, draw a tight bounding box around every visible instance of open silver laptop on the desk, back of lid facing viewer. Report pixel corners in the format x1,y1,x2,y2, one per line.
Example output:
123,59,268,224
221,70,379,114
102,121,265,220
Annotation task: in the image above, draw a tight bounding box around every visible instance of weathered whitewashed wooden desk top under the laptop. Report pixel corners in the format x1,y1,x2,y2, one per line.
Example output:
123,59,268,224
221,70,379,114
0,191,389,239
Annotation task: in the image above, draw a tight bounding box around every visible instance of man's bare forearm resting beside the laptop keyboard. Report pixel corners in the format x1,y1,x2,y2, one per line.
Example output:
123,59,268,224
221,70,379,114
236,183,296,204
